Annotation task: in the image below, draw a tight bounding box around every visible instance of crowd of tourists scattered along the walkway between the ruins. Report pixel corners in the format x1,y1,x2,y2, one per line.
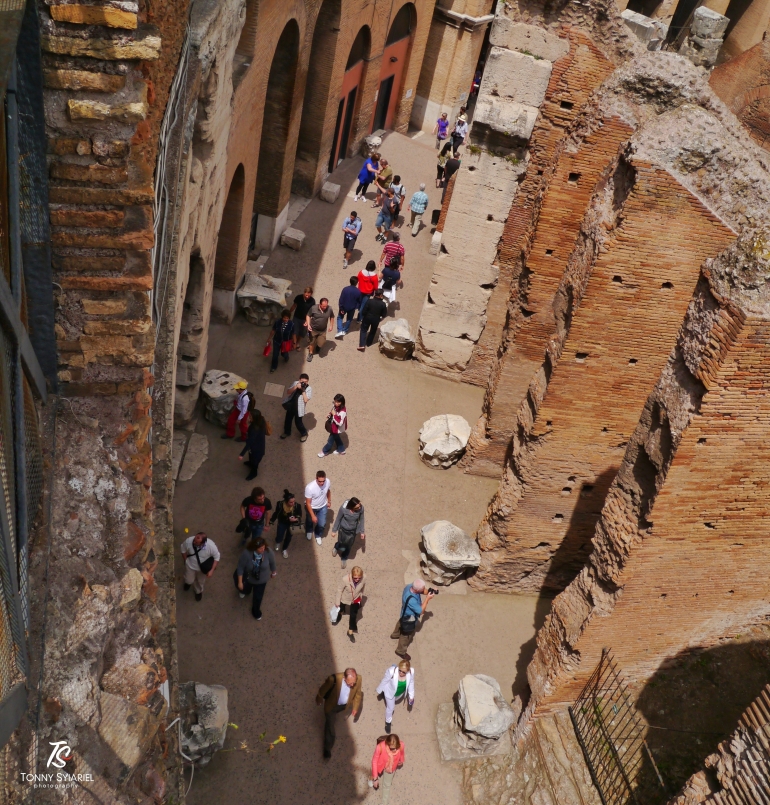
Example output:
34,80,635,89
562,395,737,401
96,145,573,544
181,122,476,803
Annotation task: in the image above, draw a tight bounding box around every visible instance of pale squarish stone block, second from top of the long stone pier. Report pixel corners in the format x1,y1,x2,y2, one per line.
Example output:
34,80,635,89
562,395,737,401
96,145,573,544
474,48,552,108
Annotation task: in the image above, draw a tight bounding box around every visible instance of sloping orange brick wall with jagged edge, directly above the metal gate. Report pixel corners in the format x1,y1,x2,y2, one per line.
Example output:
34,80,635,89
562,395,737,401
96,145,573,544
522,230,770,723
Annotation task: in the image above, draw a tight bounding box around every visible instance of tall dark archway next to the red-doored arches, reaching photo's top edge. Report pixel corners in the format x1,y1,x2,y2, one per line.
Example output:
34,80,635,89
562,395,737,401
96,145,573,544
292,0,342,196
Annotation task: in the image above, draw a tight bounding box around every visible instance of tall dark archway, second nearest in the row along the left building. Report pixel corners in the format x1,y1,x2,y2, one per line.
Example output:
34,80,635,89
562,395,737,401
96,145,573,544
252,20,299,249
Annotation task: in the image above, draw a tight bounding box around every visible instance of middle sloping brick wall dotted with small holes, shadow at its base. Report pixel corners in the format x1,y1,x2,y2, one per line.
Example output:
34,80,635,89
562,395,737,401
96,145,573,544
472,157,734,592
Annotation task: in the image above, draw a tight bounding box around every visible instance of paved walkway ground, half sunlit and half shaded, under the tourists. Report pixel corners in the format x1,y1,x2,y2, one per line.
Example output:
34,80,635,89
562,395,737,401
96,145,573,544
174,134,547,805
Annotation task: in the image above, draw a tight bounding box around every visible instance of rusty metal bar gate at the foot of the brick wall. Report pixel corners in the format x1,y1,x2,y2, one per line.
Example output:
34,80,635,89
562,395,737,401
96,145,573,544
569,649,666,805
